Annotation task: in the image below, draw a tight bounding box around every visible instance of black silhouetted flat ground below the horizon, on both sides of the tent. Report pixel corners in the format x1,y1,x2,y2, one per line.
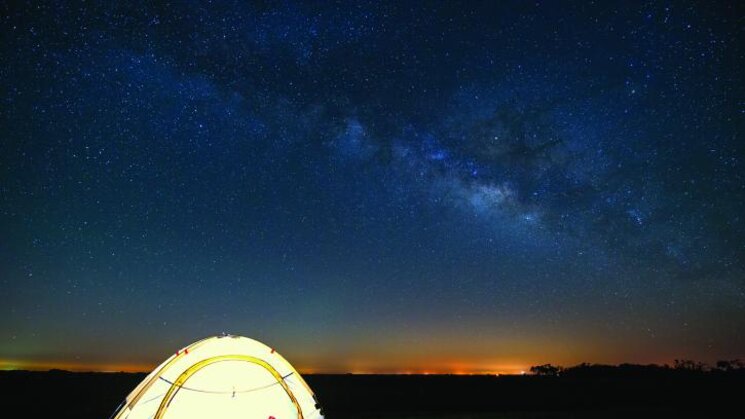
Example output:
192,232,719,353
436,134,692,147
0,369,745,419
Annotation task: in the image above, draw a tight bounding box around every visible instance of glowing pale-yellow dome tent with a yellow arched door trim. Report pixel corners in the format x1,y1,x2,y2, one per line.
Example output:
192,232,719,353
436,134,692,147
112,335,323,419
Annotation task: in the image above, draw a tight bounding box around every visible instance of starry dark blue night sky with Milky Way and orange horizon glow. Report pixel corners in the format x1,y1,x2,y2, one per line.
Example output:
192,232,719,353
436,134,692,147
0,1,745,372
